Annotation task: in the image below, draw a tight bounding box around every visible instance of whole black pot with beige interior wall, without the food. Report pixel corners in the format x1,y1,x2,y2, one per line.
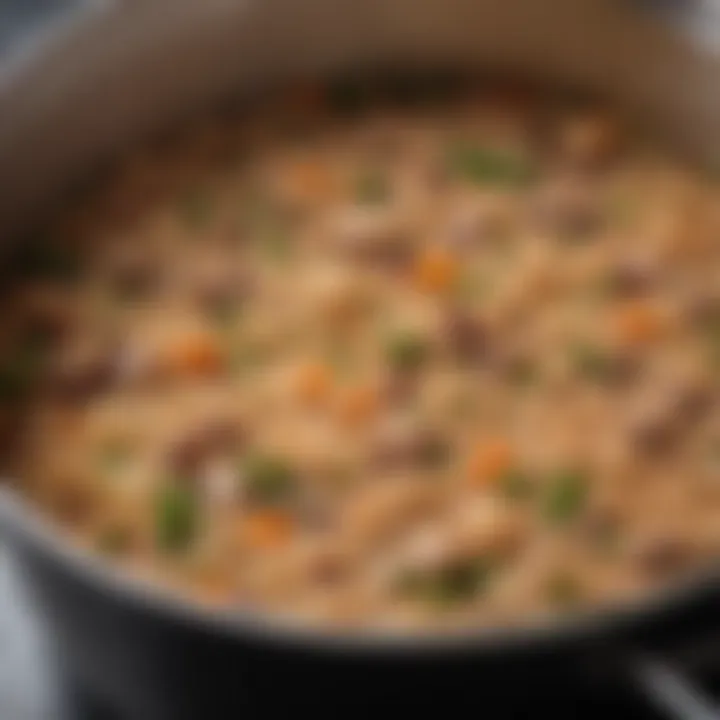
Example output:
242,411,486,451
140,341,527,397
0,0,720,720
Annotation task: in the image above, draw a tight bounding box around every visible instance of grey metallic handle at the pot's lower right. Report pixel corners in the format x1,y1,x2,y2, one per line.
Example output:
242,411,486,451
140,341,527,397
631,657,720,720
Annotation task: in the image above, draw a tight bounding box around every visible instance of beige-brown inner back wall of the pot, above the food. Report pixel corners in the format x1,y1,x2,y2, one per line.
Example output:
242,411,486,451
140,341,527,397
0,0,720,242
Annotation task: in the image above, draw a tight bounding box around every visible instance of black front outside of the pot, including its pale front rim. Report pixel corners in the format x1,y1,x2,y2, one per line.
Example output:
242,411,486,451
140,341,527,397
0,495,720,720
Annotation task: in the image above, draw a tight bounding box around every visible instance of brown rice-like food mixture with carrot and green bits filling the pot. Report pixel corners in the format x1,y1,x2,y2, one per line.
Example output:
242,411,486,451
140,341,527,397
5,80,720,629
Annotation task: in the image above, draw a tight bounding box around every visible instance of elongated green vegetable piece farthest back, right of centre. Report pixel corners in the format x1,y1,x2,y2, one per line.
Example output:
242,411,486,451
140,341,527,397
447,143,534,187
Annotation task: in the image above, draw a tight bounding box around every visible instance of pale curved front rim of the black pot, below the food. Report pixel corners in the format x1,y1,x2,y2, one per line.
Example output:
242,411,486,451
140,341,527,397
0,481,720,654
